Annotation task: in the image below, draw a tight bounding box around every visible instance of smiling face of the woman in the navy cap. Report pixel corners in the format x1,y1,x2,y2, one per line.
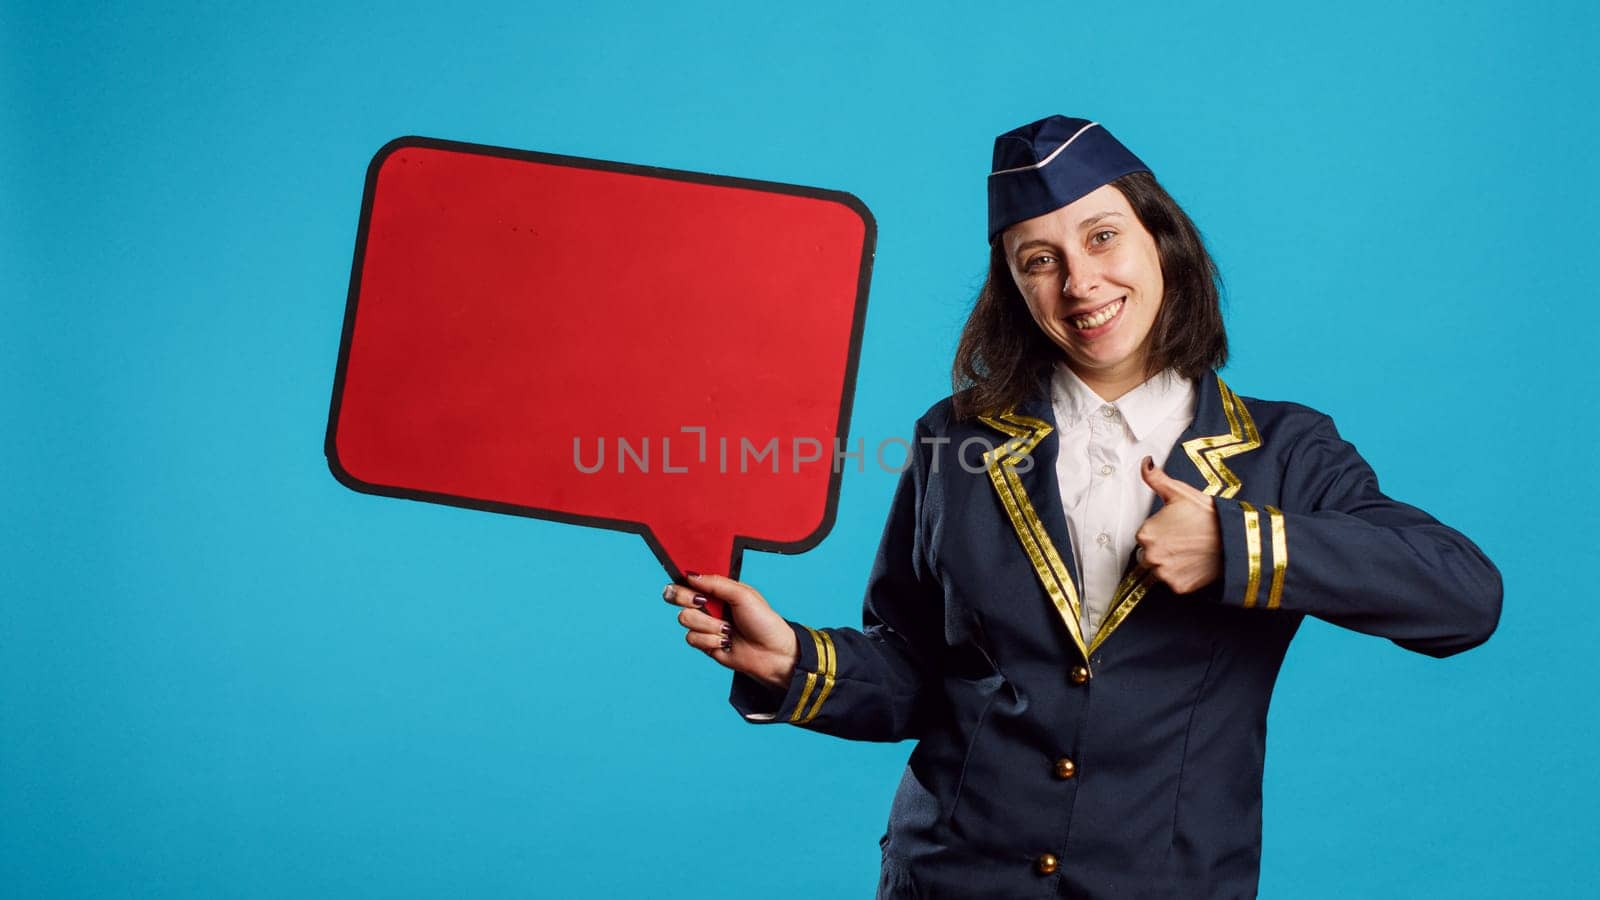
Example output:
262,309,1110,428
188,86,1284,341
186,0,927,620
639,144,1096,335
1000,184,1165,393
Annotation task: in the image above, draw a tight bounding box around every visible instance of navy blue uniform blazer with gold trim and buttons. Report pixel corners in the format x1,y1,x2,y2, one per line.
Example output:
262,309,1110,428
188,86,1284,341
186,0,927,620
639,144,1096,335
731,373,1501,900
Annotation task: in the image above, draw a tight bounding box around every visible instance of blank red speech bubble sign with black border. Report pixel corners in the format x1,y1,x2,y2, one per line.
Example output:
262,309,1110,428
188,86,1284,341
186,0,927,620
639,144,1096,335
326,138,877,578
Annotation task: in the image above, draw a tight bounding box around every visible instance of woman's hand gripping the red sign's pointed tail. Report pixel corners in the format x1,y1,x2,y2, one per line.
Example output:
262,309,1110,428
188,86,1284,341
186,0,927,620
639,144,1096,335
662,575,800,690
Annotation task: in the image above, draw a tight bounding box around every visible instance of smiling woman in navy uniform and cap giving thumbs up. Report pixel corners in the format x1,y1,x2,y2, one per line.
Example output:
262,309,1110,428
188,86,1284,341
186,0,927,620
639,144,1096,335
666,117,1501,898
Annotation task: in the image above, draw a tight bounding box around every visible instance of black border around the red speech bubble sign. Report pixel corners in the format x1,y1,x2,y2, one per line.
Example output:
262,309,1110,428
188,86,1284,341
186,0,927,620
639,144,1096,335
323,136,878,581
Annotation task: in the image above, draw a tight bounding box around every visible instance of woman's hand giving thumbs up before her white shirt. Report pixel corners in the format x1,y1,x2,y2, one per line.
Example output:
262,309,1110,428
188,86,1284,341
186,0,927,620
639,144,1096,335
1134,456,1222,594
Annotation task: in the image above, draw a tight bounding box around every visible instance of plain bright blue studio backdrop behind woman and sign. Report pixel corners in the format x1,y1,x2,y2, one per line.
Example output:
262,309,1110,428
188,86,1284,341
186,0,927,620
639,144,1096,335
0,0,1600,898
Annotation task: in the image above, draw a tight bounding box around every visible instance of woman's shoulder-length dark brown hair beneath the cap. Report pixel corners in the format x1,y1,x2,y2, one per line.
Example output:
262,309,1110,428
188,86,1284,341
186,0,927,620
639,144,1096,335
950,171,1227,420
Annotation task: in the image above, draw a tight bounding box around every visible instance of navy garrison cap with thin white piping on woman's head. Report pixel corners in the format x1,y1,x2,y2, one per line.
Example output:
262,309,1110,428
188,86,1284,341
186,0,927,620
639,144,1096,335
989,115,1150,240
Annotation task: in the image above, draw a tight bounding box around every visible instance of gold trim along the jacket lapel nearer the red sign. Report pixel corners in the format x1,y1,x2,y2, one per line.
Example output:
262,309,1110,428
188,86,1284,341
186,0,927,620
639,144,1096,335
978,410,1090,665
